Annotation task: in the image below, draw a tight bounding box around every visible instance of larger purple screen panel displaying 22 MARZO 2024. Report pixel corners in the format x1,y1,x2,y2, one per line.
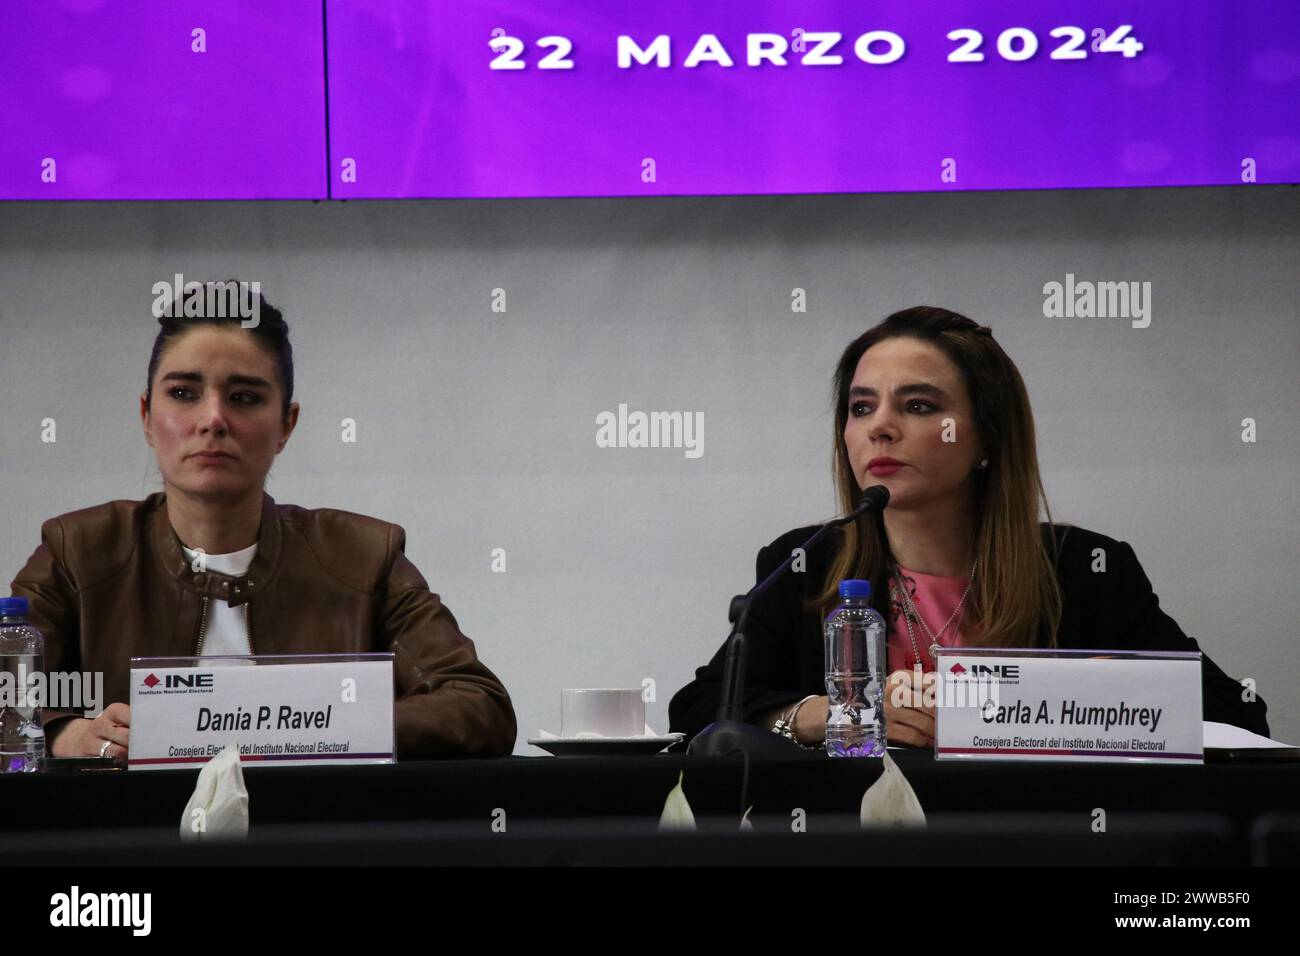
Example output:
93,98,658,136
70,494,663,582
328,0,1300,198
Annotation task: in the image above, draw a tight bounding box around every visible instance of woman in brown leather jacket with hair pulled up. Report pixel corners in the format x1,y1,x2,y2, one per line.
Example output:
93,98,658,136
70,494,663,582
12,284,516,761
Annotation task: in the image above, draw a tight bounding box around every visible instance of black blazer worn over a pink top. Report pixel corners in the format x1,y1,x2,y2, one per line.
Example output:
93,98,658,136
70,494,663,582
668,523,1269,736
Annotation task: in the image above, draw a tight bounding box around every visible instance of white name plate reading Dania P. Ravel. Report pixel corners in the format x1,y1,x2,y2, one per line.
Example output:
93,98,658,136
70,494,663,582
127,654,394,770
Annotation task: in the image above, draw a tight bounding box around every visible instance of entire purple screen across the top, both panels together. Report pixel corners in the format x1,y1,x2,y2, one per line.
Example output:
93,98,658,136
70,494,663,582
0,0,1300,199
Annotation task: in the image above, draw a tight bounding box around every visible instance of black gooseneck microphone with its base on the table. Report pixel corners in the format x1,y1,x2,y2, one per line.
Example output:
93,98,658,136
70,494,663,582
686,485,889,757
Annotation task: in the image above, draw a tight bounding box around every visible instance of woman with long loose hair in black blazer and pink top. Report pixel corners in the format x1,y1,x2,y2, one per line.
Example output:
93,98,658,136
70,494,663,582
668,307,1269,747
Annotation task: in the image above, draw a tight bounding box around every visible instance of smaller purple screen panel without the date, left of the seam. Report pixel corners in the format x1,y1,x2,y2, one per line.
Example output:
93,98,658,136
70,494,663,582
0,0,326,199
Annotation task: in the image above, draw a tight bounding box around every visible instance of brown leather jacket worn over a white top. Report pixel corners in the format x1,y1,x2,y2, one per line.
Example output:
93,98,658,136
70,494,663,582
10,492,516,758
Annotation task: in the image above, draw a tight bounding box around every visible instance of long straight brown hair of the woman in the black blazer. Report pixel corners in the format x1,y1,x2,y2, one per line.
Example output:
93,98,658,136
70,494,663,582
814,306,1061,648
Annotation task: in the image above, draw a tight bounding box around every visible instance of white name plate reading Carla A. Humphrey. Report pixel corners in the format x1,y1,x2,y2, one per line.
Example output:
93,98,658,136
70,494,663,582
935,648,1205,763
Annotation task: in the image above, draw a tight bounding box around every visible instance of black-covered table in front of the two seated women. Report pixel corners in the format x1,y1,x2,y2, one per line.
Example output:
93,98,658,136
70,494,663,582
0,750,1300,832
